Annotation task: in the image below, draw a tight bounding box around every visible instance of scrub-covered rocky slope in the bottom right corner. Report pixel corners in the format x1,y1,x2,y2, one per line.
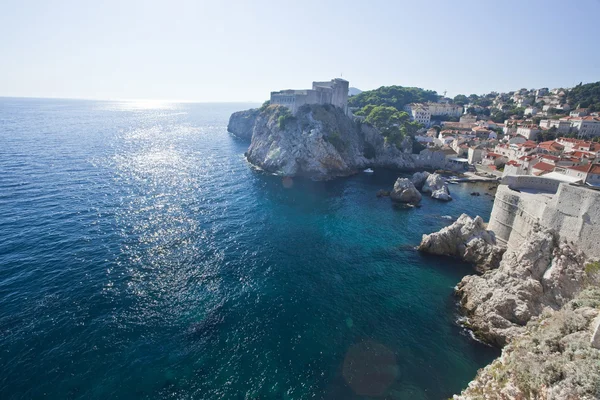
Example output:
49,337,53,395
454,287,600,400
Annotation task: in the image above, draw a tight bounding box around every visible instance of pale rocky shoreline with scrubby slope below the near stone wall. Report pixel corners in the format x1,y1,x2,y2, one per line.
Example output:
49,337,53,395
418,214,600,400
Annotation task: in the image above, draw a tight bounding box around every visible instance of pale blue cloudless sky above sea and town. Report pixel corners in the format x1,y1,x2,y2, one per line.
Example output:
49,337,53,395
0,0,600,102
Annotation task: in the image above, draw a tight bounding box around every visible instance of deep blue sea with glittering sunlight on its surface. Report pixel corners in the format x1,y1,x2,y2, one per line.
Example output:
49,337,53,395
0,98,498,399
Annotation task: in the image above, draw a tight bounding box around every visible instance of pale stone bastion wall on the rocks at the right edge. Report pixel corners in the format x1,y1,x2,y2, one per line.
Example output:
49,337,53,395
488,175,600,258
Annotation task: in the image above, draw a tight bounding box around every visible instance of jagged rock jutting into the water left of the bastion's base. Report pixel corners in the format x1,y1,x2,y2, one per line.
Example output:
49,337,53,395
418,214,505,271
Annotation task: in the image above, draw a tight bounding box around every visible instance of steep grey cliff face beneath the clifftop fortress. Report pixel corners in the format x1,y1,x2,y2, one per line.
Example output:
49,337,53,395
229,105,415,180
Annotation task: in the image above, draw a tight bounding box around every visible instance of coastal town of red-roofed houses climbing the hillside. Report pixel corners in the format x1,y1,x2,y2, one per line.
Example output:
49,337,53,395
405,89,600,186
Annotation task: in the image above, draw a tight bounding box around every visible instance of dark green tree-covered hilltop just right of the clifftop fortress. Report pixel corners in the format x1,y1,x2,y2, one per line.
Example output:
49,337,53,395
348,86,440,110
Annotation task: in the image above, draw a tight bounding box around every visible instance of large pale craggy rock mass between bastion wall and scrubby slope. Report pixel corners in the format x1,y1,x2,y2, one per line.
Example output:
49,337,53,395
456,230,586,346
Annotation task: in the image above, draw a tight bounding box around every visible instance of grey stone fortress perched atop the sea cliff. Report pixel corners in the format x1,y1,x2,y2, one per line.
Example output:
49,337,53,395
271,78,349,114
